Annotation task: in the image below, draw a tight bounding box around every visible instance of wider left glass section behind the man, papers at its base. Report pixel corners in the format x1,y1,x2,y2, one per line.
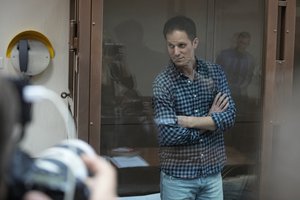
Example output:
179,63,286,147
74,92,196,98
101,0,207,195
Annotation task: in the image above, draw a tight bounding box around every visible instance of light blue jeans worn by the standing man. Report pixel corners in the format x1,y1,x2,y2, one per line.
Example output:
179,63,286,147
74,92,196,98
160,172,223,200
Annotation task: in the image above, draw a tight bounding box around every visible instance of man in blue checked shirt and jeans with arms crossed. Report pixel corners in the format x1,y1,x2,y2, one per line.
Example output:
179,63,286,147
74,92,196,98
153,16,235,200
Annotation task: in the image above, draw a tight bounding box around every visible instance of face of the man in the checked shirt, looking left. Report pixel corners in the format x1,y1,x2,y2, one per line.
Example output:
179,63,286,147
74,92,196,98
166,30,198,67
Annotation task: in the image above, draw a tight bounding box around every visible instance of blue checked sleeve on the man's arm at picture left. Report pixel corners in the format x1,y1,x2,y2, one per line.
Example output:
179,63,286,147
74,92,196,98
153,80,200,146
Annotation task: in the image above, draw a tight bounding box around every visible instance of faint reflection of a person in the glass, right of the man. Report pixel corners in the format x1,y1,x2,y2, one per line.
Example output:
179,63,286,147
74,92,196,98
216,32,256,97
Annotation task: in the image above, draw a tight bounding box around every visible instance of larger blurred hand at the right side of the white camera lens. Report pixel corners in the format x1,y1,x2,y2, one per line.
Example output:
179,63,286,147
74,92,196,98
82,155,117,200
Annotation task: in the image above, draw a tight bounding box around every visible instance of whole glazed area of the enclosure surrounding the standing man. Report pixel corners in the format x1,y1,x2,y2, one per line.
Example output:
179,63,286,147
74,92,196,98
101,0,264,199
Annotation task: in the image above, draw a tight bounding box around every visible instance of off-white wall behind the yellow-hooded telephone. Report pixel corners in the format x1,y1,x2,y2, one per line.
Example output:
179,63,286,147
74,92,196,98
0,0,69,154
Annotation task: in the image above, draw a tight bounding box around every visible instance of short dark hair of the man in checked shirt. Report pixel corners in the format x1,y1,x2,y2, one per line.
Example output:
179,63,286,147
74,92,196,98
163,15,197,41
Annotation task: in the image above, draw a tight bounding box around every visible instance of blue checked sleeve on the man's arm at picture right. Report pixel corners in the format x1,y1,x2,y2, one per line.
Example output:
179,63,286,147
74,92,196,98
211,66,236,131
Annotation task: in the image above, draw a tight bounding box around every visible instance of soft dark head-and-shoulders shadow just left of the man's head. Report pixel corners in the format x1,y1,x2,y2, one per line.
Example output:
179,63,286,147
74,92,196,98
114,19,167,96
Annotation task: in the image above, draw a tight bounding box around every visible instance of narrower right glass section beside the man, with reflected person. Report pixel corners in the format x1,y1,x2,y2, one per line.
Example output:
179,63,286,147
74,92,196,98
214,0,264,200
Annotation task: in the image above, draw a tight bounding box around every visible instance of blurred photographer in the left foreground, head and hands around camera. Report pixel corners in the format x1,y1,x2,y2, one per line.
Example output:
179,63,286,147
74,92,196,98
0,76,117,200
